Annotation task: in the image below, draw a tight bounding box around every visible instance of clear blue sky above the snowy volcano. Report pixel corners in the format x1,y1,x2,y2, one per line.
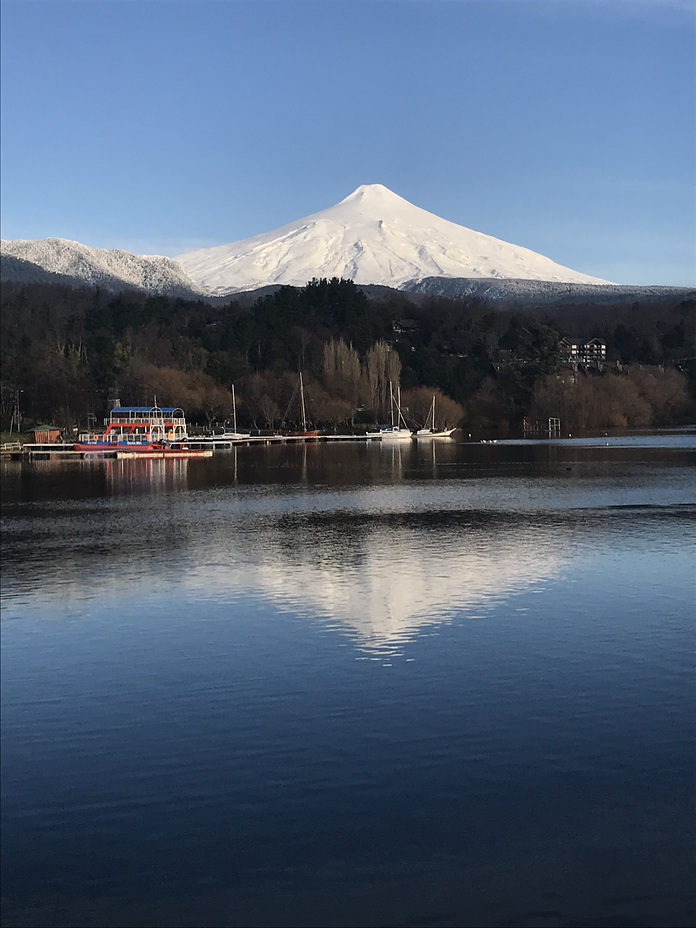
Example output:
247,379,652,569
1,0,696,284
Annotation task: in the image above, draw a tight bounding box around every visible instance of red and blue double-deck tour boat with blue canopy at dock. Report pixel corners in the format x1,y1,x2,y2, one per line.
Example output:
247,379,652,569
73,402,212,457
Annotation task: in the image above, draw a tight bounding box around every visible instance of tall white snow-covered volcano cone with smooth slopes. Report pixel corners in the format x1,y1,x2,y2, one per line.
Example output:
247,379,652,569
176,184,607,295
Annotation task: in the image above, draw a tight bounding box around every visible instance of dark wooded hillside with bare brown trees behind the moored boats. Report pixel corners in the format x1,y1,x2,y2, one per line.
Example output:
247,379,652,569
1,279,696,434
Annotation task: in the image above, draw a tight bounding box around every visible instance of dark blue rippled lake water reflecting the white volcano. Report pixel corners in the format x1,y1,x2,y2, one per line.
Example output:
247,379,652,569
2,432,696,928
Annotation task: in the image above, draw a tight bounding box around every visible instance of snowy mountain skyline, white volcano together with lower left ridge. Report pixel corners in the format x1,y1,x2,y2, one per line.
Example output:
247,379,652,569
2,184,609,297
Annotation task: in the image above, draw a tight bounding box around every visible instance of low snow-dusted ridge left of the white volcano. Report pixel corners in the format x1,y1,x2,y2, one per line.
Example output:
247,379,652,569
1,238,200,298
